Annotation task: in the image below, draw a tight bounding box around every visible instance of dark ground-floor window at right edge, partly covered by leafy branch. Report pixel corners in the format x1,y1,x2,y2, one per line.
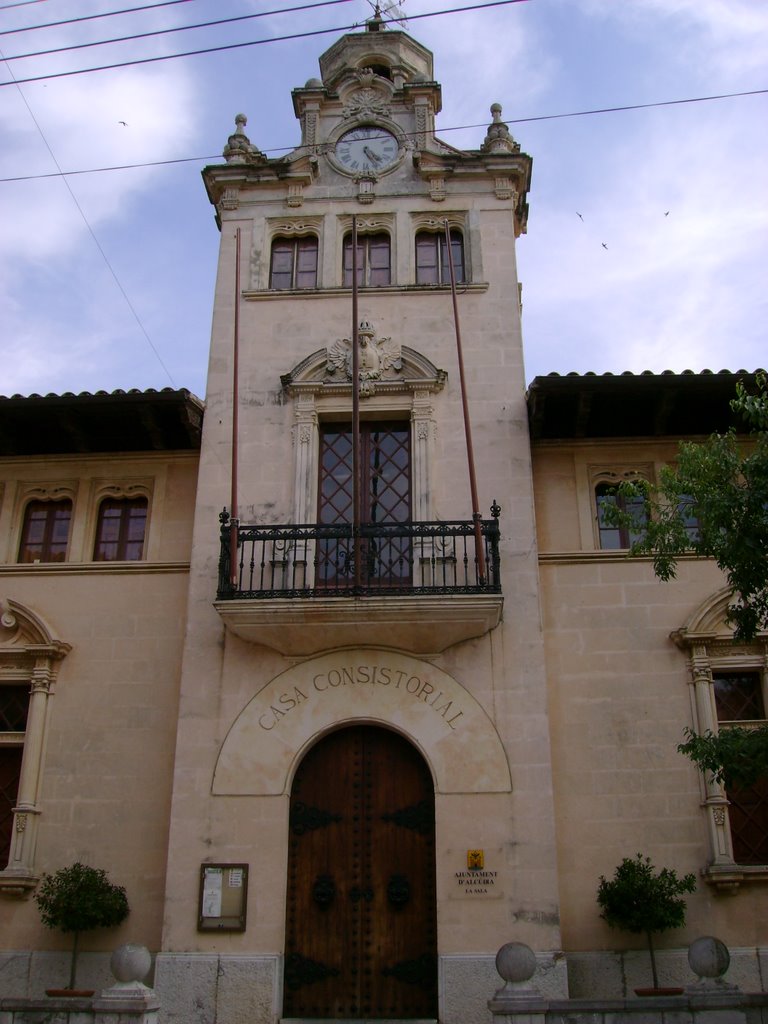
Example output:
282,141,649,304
712,670,768,864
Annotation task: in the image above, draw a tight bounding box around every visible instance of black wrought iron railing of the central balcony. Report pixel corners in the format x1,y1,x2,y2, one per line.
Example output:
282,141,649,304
217,503,502,601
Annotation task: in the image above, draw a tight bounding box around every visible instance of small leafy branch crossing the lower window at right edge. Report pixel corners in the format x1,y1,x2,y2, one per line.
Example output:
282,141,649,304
678,725,768,788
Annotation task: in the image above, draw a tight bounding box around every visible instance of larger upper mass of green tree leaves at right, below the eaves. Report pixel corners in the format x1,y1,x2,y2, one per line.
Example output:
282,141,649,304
604,374,768,641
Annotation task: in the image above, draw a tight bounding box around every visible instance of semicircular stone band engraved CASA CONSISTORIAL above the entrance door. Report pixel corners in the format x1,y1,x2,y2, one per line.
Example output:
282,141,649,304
212,648,512,796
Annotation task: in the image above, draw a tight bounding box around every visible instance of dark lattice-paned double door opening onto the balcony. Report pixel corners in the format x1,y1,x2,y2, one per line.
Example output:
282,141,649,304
317,421,412,588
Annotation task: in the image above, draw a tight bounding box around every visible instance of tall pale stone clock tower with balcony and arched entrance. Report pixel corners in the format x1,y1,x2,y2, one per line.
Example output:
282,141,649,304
157,9,566,1024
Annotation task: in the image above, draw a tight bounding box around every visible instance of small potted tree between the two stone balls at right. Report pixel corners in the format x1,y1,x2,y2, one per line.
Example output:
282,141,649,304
597,853,696,995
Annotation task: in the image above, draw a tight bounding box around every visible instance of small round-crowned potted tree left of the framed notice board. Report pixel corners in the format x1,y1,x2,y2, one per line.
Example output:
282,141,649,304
35,862,129,995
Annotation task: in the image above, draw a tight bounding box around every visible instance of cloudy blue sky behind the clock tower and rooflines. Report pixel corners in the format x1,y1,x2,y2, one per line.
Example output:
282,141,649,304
0,0,768,397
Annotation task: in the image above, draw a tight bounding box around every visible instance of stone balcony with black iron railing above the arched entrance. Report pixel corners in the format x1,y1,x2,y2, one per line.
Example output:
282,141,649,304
215,505,503,655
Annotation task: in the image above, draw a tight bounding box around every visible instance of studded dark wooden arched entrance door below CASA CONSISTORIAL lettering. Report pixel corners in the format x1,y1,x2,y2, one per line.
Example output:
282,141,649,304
284,725,437,1019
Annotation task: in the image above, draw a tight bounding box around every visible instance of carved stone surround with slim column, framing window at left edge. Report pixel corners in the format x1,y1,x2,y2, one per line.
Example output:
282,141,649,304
0,600,71,897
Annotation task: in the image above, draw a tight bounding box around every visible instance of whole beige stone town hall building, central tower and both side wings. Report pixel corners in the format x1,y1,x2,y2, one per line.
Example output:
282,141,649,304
0,18,768,1024
